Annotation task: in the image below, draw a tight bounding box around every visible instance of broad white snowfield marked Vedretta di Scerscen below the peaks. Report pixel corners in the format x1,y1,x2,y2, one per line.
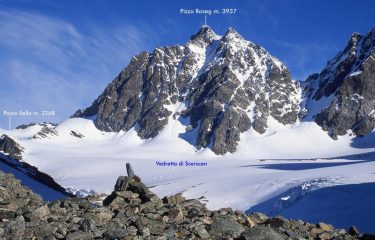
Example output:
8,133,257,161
0,117,375,232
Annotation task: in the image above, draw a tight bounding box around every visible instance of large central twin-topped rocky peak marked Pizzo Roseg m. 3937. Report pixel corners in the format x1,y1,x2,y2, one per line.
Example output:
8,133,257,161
73,27,299,154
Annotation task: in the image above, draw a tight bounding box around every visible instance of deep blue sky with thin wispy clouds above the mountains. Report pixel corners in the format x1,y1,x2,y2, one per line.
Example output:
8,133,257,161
0,0,375,128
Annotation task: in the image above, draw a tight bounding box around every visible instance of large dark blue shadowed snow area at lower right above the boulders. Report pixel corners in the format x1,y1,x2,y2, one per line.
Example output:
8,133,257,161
246,183,375,233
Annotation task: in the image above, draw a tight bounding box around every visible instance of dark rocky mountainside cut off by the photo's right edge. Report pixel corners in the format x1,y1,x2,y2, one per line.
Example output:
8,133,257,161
304,28,375,139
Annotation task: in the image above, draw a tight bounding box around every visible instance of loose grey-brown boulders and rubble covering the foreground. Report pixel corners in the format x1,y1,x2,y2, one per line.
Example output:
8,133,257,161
0,171,375,240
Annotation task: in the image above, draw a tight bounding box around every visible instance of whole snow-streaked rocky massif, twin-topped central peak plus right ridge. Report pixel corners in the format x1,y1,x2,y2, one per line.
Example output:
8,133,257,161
73,26,375,154
